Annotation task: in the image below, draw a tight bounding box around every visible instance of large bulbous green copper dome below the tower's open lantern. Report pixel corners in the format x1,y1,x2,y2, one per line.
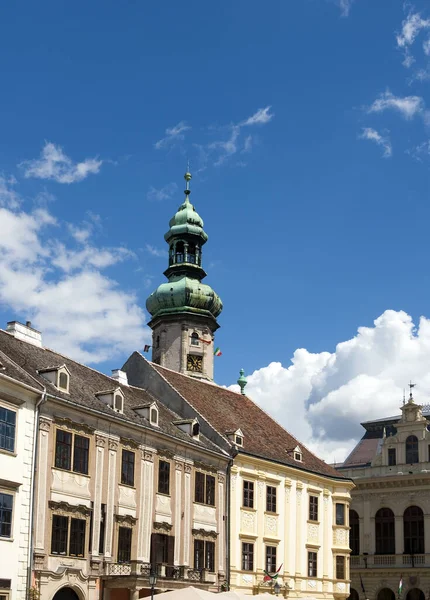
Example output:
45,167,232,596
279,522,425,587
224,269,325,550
146,276,222,318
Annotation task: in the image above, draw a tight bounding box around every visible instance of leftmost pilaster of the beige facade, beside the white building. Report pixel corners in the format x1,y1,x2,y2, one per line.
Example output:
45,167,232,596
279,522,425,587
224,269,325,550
34,417,52,551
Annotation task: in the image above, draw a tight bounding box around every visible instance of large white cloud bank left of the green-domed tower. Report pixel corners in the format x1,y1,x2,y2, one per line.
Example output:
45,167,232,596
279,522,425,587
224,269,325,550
0,178,146,363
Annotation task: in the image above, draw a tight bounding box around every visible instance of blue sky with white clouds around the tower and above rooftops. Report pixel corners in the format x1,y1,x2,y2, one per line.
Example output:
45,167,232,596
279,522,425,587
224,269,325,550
0,0,430,456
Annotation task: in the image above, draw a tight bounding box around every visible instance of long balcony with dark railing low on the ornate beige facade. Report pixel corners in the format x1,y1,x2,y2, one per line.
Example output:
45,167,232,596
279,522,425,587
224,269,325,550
105,561,216,583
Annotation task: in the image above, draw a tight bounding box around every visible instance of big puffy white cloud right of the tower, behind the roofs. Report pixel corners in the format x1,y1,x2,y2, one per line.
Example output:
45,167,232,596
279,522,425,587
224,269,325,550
228,310,430,462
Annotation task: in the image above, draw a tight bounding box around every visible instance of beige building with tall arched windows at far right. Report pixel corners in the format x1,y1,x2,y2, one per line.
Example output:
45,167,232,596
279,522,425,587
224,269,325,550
337,391,430,600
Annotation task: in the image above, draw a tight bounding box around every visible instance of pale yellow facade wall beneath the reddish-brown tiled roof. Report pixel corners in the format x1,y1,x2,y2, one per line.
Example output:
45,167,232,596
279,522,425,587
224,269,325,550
230,454,353,598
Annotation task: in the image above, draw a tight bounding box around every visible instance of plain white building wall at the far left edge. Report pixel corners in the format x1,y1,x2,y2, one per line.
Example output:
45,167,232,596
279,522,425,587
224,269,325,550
0,379,38,600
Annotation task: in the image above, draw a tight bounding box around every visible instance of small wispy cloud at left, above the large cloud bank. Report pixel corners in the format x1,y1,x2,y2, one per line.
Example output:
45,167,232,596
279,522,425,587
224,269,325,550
19,142,103,183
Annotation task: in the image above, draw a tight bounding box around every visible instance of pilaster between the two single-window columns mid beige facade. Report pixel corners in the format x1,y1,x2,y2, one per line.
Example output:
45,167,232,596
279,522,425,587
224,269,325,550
137,449,154,563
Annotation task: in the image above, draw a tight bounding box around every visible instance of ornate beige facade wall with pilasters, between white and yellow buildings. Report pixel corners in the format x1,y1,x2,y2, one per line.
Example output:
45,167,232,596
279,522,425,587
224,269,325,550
35,403,226,600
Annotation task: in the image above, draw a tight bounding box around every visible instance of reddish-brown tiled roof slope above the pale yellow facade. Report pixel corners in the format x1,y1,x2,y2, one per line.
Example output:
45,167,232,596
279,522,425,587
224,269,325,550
149,363,343,479
